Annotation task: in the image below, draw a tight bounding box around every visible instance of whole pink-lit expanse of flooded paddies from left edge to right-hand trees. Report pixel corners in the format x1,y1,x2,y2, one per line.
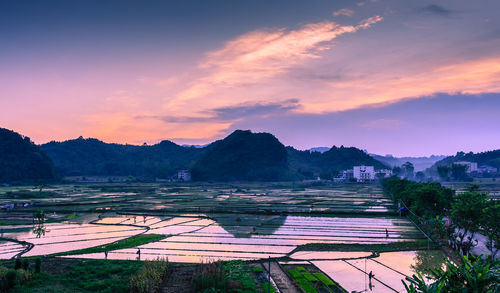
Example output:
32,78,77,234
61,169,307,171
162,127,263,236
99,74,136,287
0,214,422,262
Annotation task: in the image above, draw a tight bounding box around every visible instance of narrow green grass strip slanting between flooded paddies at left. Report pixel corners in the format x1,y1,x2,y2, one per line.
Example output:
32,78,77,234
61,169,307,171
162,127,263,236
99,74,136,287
51,234,167,256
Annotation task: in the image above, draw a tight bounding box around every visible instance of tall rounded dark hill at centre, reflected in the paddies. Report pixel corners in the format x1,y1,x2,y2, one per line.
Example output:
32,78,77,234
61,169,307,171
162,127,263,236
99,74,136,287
191,130,290,181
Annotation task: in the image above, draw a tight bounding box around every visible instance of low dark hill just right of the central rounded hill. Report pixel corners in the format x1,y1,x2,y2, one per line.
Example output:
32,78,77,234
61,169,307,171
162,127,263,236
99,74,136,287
287,146,389,178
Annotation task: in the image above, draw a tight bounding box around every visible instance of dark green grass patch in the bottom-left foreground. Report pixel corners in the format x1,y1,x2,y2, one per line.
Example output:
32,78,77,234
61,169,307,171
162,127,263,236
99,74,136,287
10,260,143,293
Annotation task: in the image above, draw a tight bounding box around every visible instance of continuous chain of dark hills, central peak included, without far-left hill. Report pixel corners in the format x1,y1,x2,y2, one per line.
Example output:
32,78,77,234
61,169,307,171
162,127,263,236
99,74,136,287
0,130,394,181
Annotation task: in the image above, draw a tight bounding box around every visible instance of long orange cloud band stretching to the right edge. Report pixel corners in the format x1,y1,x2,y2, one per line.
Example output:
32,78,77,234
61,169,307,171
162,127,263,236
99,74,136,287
302,57,500,113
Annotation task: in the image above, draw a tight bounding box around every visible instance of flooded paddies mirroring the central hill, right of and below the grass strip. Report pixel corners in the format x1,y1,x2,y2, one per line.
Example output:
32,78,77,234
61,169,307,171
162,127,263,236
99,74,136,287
61,215,421,262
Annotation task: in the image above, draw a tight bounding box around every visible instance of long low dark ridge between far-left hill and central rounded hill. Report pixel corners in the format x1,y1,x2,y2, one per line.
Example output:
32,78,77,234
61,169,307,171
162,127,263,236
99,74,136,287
41,137,203,178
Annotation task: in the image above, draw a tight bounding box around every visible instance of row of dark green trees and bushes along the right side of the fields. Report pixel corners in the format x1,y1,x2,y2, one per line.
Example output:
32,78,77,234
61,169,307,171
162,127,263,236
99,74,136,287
381,177,500,292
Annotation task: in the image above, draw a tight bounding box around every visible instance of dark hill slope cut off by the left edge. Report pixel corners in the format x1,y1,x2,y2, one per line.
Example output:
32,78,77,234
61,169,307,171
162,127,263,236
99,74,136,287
0,128,57,183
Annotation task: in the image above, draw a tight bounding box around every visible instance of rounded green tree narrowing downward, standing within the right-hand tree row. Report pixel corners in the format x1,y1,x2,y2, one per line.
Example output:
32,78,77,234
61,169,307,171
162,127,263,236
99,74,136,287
451,192,487,254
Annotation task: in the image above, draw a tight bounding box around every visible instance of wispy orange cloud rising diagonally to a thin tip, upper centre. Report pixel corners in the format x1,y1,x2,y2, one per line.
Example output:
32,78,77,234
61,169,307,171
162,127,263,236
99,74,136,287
166,16,383,111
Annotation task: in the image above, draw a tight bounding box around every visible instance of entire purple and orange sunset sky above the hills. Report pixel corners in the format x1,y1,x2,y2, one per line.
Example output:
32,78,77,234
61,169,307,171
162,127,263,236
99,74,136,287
0,0,500,156
